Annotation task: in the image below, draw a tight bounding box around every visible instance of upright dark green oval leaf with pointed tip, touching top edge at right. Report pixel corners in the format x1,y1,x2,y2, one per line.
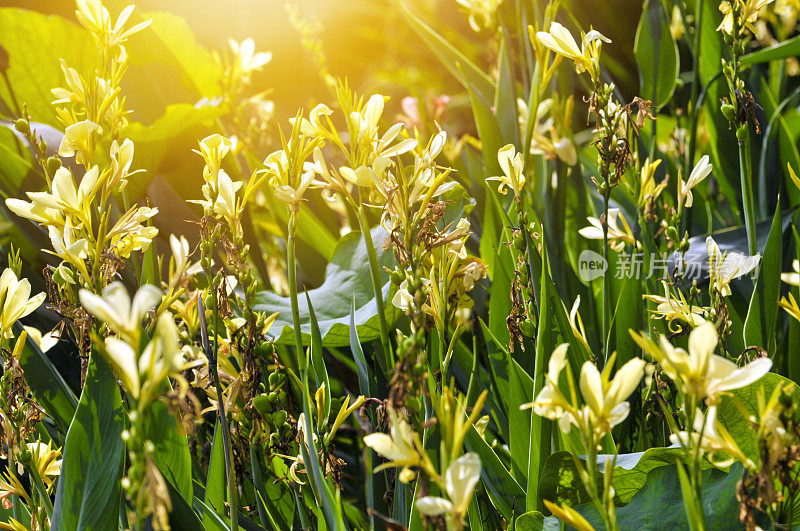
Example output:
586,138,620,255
633,0,680,110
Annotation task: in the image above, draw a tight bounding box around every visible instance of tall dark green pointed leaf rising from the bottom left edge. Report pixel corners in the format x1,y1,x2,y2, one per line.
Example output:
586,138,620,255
52,349,125,531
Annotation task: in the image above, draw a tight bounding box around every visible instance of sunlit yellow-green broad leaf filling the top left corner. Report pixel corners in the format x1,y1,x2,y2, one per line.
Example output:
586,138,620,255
0,7,97,127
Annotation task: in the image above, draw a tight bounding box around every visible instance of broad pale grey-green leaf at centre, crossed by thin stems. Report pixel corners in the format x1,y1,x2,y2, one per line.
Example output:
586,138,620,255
254,227,398,347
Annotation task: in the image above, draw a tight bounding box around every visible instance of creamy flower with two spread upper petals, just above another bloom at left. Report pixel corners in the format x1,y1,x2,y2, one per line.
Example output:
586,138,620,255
79,282,161,344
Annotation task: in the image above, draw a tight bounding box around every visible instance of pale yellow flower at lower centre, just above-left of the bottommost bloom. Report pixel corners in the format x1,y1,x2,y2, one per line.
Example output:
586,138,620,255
364,409,424,483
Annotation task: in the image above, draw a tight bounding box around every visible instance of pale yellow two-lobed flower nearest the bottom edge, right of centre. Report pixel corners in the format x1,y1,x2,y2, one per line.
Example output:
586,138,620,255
416,452,481,528
